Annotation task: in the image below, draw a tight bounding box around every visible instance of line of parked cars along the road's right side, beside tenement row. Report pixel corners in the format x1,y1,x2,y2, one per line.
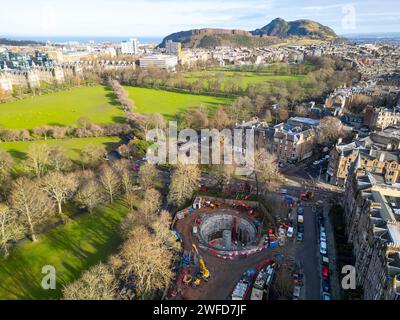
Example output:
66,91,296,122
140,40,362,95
318,211,331,300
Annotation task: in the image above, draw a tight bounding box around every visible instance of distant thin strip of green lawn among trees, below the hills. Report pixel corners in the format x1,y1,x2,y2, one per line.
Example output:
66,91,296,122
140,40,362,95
184,68,305,90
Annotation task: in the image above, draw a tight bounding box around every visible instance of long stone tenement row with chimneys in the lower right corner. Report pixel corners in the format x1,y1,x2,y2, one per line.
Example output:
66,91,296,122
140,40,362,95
344,162,400,300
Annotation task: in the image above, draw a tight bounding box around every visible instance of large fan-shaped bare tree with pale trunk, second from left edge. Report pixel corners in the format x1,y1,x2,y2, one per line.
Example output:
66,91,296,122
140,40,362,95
10,177,54,242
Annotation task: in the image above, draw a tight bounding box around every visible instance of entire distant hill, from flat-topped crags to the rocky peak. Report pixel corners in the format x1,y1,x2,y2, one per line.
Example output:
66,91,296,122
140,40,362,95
159,18,336,48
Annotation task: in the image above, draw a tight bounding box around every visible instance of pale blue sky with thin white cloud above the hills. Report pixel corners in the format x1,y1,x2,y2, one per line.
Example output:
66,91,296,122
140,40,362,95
0,0,400,37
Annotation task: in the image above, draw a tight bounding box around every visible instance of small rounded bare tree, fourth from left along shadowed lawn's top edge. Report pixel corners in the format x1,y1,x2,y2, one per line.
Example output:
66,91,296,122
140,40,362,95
75,179,104,213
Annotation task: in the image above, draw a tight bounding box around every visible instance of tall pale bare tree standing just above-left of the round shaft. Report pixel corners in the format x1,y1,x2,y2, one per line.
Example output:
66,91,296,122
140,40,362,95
168,164,200,207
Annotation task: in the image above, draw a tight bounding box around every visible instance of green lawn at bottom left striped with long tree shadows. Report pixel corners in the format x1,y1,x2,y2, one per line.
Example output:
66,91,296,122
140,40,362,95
0,202,128,300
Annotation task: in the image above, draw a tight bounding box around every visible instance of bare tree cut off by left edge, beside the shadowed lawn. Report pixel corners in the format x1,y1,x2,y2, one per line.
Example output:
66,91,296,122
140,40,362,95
0,203,23,257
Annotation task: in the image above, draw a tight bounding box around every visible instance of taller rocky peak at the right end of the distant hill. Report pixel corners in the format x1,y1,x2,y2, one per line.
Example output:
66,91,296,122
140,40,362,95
251,18,337,39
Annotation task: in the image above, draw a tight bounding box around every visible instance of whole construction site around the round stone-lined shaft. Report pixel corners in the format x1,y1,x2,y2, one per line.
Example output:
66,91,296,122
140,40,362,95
165,197,279,300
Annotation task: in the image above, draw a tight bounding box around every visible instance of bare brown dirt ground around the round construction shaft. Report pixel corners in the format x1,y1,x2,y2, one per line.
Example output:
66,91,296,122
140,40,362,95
176,206,279,300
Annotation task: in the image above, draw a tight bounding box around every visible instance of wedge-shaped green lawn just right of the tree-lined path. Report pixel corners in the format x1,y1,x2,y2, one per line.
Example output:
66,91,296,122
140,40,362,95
125,87,232,120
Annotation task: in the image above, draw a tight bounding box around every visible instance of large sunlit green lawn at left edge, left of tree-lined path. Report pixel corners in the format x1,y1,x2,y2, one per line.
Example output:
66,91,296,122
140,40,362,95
0,86,124,129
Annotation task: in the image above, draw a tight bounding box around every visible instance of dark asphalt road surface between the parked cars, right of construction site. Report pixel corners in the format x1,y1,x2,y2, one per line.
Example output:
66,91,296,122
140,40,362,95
296,208,321,300
